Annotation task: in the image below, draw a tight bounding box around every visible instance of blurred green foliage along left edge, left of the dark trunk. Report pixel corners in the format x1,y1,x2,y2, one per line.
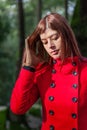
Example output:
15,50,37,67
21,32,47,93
0,1,18,105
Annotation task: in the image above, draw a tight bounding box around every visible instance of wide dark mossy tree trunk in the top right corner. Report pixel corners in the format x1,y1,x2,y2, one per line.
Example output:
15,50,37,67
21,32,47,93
71,0,87,56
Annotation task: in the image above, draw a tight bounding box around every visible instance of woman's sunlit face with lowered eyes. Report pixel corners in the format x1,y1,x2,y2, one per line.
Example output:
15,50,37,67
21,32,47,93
40,28,62,59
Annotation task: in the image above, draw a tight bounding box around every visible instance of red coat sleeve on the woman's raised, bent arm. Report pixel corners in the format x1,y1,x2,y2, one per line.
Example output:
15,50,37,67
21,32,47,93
10,68,39,114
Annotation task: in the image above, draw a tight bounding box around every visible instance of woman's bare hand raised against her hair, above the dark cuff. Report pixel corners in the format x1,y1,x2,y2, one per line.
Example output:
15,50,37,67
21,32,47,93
23,37,41,68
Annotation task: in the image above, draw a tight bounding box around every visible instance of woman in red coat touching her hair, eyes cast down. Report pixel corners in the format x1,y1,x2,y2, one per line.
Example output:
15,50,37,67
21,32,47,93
10,13,87,130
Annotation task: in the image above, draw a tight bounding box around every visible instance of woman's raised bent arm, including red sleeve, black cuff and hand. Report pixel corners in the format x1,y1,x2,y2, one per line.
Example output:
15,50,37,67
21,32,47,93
10,37,41,114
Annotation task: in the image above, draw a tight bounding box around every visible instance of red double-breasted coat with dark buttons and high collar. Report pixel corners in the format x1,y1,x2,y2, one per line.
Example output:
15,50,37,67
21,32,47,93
10,57,87,130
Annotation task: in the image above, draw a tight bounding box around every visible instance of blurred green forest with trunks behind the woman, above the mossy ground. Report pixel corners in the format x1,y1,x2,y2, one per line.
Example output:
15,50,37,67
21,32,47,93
0,0,87,129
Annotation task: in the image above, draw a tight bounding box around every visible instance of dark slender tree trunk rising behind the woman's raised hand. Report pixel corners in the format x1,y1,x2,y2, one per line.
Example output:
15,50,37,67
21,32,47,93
17,0,25,74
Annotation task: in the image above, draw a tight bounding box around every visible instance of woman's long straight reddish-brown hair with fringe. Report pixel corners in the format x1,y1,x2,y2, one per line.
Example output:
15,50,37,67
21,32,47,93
23,13,81,61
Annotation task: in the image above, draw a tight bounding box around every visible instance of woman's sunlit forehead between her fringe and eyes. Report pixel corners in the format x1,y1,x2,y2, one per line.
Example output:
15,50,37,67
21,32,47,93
40,28,58,39
